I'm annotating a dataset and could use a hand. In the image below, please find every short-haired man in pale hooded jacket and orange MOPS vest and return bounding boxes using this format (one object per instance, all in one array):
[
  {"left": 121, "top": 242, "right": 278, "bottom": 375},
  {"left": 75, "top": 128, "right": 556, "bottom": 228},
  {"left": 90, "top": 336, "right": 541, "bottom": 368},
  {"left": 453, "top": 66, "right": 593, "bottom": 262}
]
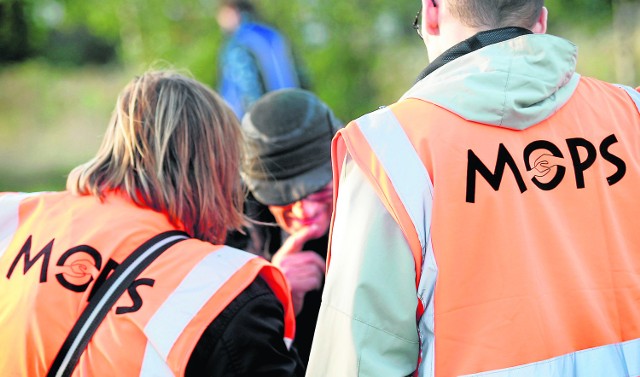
[{"left": 307, "top": 0, "right": 640, "bottom": 377}]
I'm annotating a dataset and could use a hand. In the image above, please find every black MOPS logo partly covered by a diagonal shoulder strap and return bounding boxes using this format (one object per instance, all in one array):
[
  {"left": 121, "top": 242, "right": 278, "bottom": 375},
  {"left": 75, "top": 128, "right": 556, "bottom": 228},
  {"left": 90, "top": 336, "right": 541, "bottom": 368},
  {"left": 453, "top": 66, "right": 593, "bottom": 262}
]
[{"left": 6, "top": 236, "right": 155, "bottom": 314}]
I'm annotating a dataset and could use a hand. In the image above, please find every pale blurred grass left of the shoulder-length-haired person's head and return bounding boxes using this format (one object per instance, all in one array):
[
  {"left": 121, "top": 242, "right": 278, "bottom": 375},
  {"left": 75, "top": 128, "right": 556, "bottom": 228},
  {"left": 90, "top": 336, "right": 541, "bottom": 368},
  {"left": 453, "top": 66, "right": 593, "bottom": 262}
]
[{"left": 0, "top": 61, "right": 132, "bottom": 191}]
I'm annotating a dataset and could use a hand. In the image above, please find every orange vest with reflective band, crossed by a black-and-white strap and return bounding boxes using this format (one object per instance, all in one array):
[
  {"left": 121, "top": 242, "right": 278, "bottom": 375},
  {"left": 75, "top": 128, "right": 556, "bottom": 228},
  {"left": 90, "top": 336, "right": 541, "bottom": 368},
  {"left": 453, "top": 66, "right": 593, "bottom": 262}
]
[{"left": 0, "top": 192, "right": 295, "bottom": 377}]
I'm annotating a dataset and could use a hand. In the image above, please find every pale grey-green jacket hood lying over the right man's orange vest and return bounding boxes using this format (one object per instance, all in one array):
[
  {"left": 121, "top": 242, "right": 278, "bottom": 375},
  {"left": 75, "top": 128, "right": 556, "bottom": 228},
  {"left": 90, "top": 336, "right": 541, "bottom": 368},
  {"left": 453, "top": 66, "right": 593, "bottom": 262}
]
[{"left": 402, "top": 34, "right": 580, "bottom": 130}]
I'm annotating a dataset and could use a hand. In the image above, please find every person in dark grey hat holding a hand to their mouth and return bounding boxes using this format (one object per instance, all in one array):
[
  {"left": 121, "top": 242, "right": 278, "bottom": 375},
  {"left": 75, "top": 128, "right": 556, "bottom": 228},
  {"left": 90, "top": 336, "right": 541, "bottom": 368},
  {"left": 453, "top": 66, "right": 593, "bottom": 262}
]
[{"left": 241, "top": 88, "right": 343, "bottom": 363}]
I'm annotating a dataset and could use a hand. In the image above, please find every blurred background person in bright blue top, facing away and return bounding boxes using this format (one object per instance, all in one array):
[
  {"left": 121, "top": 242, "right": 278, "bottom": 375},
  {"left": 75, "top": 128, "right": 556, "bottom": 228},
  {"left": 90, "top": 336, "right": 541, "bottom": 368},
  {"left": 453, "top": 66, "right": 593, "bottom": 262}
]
[{"left": 217, "top": 0, "right": 304, "bottom": 119}]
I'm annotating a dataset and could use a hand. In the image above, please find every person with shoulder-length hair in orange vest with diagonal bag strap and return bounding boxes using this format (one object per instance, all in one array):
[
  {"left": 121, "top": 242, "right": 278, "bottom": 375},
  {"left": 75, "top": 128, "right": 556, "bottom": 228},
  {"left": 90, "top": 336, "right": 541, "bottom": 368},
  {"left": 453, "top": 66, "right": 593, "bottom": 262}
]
[{"left": 0, "top": 71, "right": 304, "bottom": 376}]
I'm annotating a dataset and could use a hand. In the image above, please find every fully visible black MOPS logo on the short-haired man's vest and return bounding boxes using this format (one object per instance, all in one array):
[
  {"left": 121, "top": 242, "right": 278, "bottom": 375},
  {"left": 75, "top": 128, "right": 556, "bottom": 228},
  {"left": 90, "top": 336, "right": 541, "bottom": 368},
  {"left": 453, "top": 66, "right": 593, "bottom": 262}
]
[{"left": 466, "top": 134, "right": 627, "bottom": 203}]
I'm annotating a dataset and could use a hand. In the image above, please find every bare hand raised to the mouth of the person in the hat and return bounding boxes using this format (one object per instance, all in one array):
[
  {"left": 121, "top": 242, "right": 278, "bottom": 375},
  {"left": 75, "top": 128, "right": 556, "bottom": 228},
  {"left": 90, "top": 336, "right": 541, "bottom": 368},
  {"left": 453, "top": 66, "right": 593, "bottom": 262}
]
[{"left": 271, "top": 227, "right": 326, "bottom": 315}]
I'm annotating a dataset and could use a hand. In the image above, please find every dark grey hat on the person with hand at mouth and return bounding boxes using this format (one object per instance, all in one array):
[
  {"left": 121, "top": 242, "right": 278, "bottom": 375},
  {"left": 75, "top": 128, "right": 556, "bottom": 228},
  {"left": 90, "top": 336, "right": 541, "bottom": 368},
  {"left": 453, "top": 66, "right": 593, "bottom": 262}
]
[{"left": 241, "top": 89, "right": 342, "bottom": 205}]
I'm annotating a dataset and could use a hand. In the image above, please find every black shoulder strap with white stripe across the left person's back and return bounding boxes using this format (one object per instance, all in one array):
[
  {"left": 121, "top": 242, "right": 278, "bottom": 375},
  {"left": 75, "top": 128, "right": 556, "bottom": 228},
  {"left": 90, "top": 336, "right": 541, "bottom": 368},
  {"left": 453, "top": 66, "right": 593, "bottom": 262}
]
[{"left": 47, "top": 231, "right": 189, "bottom": 377}]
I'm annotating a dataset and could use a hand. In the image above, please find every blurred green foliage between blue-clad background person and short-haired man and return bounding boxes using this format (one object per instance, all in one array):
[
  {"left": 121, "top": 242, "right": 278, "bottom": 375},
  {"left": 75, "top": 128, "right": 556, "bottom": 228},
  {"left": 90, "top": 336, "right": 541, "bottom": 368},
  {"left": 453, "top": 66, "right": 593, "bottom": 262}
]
[{"left": 260, "top": 0, "right": 420, "bottom": 120}]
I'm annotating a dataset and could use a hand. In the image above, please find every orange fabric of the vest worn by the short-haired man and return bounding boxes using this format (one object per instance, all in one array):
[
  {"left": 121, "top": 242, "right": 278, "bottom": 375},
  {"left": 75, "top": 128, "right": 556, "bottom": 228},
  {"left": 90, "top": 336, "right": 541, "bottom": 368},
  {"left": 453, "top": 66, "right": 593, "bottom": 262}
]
[{"left": 342, "top": 78, "right": 640, "bottom": 376}]
